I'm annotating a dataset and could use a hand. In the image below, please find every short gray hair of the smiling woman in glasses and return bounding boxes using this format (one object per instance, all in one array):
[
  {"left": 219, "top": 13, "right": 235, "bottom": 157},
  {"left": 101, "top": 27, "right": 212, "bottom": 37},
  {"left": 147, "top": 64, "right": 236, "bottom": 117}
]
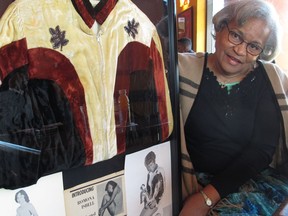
[{"left": 212, "top": 0, "right": 282, "bottom": 61}]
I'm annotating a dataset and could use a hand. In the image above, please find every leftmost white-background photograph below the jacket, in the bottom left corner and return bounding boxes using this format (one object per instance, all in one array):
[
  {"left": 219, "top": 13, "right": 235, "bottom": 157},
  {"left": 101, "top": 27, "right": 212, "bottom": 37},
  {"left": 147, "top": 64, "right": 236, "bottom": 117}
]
[{"left": 0, "top": 173, "right": 66, "bottom": 216}]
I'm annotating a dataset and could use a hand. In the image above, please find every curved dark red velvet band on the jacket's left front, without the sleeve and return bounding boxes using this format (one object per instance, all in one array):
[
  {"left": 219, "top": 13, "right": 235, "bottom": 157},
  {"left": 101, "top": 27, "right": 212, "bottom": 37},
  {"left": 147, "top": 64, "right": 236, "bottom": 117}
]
[{"left": 29, "top": 48, "right": 93, "bottom": 164}]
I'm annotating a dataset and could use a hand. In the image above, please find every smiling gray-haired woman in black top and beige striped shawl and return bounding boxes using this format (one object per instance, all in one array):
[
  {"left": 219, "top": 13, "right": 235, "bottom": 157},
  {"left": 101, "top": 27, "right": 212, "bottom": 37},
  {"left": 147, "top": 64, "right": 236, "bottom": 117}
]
[{"left": 178, "top": 0, "right": 288, "bottom": 216}]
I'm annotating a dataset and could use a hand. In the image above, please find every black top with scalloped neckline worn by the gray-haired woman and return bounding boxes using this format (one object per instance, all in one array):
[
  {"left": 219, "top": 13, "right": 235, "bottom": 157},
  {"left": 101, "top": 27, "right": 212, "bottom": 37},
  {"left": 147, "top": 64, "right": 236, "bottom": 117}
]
[{"left": 185, "top": 57, "right": 280, "bottom": 197}]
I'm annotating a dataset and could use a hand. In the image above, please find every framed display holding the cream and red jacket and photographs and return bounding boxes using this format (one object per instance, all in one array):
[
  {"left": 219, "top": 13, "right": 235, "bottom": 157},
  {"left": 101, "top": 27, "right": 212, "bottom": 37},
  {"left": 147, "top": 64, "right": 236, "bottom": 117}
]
[{"left": 0, "top": 0, "right": 181, "bottom": 216}]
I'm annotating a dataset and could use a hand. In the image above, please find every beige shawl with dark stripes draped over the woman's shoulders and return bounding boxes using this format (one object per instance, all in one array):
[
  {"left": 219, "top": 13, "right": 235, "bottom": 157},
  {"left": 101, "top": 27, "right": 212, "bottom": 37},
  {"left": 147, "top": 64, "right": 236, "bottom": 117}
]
[{"left": 178, "top": 53, "right": 288, "bottom": 199}]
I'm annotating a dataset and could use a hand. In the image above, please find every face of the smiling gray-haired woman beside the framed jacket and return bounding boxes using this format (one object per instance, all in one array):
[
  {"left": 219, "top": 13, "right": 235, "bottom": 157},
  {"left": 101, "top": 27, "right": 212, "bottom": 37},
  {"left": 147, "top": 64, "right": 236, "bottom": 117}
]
[{"left": 215, "top": 19, "right": 270, "bottom": 75}]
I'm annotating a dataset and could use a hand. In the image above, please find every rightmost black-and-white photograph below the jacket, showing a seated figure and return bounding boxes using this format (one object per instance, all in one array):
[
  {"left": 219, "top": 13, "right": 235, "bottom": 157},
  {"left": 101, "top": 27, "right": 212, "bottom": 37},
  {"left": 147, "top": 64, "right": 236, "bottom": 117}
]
[{"left": 125, "top": 142, "right": 172, "bottom": 216}]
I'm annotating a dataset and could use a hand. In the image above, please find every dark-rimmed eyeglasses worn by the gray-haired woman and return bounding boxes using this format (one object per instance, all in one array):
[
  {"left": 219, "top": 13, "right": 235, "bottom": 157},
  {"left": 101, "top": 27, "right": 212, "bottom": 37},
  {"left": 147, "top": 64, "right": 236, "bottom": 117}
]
[{"left": 226, "top": 25, "right": 263, "bottom": 56}]
